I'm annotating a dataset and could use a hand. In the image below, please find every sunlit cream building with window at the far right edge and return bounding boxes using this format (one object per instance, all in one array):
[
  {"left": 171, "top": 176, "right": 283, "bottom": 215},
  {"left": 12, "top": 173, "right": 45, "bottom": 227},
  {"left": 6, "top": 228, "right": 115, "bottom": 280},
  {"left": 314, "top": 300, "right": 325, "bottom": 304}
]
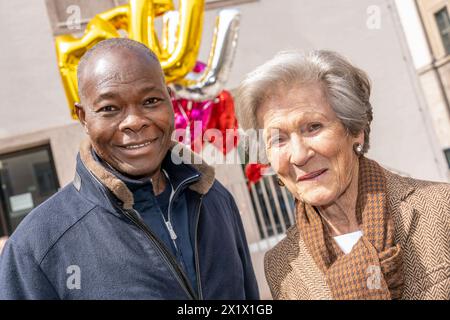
[{"left": 396, "top": 0, "right": 450, "bottom": 172}]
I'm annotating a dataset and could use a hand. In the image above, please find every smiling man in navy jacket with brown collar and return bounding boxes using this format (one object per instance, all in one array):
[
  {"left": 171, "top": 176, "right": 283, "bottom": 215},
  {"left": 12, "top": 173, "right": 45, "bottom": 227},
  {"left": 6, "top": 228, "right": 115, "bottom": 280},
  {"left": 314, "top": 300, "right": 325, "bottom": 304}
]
[{"left": 0, "top": 39, "right": 258, "bottom": 299}]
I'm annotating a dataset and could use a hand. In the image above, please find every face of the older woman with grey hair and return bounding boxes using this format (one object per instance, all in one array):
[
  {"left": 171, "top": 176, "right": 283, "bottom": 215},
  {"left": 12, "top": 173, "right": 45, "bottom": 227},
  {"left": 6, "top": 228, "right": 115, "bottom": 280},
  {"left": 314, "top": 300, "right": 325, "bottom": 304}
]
[{"left": 257, "top": 83, "right": 364, "bottom": 206}]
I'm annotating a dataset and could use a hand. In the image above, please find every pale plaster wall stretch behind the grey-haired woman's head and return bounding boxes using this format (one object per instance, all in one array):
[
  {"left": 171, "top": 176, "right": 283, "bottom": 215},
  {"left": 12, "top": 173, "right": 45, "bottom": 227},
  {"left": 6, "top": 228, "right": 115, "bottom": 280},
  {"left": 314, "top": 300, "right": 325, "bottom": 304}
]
[{"left": 201, "top": 0, "right": 447, "bottom": 181}]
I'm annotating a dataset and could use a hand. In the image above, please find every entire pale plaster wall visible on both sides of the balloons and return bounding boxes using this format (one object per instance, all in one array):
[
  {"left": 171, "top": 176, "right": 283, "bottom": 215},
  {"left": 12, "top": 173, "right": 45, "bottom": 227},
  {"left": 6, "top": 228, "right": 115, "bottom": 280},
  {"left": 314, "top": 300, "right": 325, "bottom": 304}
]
[{"left": 0, "top": 0, "right": 447, "bottom": 180}]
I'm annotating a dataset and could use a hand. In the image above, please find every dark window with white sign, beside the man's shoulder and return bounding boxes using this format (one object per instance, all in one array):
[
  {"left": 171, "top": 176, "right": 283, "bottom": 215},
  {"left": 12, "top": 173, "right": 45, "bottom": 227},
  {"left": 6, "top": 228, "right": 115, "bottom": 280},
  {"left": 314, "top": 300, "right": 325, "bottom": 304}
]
[{"left": 0, "top": 145, "right": 59, "bottom": 234}]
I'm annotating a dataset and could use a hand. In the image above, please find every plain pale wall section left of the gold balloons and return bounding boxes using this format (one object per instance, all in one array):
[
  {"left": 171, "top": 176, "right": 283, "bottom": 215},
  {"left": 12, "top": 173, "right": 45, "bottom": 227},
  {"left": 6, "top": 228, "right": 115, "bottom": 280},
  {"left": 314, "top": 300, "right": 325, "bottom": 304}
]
[{"left": 0, "top": 0, "right": 73, "bottom": 138}]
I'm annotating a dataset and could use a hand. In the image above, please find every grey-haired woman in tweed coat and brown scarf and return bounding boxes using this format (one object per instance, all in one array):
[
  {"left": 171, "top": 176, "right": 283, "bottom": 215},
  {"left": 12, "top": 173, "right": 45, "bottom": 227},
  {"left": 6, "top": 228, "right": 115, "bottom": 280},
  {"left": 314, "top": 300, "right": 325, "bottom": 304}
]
[{"left": 237, "top": 51, "right": 450, "bottom": 299}]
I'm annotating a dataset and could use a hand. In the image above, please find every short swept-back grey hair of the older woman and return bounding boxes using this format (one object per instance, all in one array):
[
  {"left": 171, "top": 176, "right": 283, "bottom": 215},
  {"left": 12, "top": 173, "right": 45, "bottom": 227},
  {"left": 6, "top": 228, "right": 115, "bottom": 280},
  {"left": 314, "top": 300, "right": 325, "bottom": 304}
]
[{"left": 236, "top": 50, "right": 373, "bottom": 152}]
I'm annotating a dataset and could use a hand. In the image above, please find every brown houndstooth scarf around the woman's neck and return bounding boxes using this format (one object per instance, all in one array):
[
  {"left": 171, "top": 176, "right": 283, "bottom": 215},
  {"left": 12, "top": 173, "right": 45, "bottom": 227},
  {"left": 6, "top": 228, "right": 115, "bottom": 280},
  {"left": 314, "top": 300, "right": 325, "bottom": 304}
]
[{"left": 297, "top": 157, "right": 404, "bottom": 300}]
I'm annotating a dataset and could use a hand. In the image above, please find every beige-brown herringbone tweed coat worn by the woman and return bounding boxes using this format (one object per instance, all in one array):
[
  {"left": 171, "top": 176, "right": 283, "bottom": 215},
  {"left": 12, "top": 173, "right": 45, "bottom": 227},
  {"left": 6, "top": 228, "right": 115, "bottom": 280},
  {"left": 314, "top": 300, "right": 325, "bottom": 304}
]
[{"left": 264, "top": 170, "right": 450, "bottom": 299}]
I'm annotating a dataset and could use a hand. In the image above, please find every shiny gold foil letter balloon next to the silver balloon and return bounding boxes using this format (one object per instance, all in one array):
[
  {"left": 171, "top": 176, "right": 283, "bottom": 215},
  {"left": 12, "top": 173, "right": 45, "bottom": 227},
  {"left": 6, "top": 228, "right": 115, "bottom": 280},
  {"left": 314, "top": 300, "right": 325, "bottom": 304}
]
[{"left": 99, "top": 0, "right": 205, "bottom": 82}]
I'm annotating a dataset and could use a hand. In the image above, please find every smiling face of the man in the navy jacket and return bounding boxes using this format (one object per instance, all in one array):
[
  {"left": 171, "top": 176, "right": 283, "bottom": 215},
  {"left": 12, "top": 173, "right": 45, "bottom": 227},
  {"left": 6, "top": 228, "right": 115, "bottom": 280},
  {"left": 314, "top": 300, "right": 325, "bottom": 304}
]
[{"left": 77, "top": 48, "right": 174, "bottom": 177}]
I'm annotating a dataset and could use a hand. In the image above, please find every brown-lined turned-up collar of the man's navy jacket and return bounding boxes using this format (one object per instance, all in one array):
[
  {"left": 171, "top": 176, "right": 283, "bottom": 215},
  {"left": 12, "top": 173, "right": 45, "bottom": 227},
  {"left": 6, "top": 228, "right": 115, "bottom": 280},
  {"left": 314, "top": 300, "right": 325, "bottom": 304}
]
[{"left": 80, "top": 139, "right": 215, "bottom": 209}]
